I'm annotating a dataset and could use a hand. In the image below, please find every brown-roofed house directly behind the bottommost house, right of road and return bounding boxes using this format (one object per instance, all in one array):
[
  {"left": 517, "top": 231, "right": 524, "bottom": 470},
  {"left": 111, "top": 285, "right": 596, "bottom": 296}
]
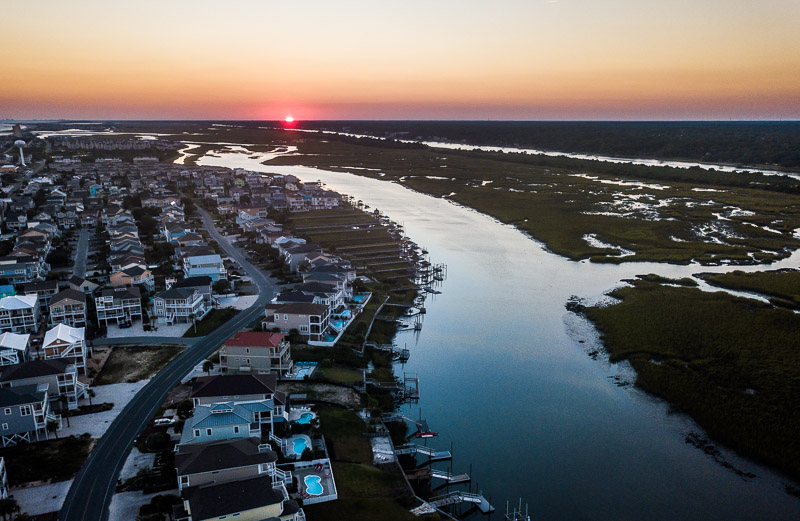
[{"left": 175, "top": 438, "right": 292, "bottom": 490}]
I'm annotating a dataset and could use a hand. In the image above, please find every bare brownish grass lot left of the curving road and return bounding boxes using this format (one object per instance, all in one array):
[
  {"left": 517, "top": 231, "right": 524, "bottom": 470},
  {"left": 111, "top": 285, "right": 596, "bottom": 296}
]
[{"left": 93, "top": 346, "right": 183, "bottom": 385}]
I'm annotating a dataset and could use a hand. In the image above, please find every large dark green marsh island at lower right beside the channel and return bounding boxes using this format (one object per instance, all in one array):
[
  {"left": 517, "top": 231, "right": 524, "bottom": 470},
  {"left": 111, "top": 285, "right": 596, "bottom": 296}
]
[{"left": 586, "top": 280, "right": 800, "bottom": 478}]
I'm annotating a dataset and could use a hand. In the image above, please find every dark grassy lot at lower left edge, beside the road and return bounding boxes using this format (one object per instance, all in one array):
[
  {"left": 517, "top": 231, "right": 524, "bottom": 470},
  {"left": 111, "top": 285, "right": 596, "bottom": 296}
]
[{"left": 0, "top": 430, "right": 94, "bottom": 485}]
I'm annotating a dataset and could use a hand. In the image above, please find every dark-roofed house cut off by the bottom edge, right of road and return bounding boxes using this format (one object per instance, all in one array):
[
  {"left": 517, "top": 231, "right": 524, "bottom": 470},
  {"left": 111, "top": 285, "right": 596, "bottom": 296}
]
[{"left": 174, "top": 476, "right": 306, "bottom": 521}]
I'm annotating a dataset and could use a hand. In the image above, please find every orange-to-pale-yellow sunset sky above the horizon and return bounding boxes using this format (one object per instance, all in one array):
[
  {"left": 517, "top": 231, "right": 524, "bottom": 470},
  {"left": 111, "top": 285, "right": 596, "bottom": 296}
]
[{"left": 0, "top": 0, "right": 800, "bottom": 120}]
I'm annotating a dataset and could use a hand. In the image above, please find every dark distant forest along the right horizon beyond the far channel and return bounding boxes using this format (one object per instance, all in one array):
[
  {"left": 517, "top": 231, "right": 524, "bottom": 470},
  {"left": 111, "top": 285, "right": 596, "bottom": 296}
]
[{"left": 288, "top": 121, "right": 800, "bottom": 168}]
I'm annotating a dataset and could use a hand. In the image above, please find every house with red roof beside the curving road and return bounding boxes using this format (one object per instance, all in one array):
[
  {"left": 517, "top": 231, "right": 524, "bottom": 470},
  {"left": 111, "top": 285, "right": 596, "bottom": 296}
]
[{"left": 219, "top": 331, "right": 294, "bottom": 375}]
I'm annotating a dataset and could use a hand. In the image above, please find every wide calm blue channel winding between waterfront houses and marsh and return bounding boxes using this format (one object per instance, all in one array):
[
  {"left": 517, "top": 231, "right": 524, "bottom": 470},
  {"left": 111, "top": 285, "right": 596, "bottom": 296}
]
[{"left": 198, "top": 151, "right": 800, "bottom": 521}]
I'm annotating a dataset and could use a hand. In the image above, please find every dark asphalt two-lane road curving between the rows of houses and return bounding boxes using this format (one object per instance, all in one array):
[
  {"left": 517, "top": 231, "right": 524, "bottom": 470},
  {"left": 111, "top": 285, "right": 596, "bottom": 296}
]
[{"left": 58, "top": 208, "right": 275, "bottom": 521}]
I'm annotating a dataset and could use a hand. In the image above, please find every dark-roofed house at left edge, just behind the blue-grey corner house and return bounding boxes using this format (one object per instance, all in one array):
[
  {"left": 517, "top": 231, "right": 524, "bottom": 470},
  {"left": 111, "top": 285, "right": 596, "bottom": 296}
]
[{"left": 0, "top": 358, "right": 89, "bottom": 410}]
